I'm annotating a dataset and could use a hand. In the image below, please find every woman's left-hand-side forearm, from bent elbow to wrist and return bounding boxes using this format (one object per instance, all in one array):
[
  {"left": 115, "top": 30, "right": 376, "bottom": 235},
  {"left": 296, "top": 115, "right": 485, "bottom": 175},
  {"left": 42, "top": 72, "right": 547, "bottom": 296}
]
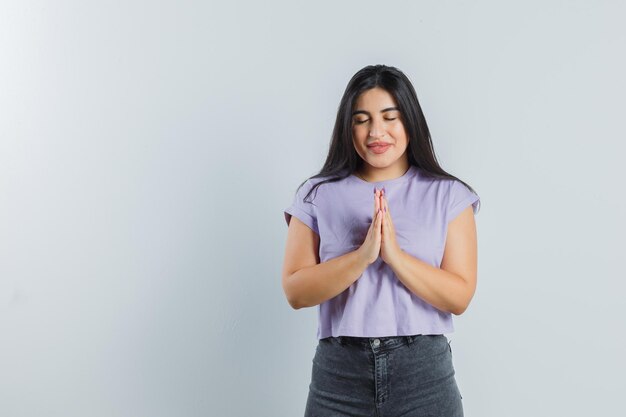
[{"left": 285, "top": 250, "right": 368, "bottom": 309}]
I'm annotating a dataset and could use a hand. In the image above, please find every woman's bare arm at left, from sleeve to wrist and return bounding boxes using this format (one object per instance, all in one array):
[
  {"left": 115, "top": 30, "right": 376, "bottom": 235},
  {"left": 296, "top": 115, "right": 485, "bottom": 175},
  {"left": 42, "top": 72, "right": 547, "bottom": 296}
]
[{"left": 282, "top": 216, "right": 369, "bottom": 310}]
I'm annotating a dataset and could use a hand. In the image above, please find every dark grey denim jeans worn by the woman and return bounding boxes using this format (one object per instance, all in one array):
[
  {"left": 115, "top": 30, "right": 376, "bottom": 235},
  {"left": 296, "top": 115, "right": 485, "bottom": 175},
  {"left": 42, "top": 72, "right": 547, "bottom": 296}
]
[{"left": 304, "top": 334, "right": 463, "bottom": 417}]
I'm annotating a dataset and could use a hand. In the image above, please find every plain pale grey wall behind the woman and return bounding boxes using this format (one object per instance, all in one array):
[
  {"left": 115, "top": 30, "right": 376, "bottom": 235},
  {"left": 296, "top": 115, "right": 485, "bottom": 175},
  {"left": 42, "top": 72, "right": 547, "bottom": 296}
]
[{"left": 0, "top": 0, "right": 626, "bottom": 417}]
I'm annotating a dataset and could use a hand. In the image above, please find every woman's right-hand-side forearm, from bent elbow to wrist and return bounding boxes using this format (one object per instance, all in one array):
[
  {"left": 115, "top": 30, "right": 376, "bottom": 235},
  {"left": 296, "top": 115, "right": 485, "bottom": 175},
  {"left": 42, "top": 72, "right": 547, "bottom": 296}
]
[{"left": 389, "top": 251, "right": 473, "bottom": 315}]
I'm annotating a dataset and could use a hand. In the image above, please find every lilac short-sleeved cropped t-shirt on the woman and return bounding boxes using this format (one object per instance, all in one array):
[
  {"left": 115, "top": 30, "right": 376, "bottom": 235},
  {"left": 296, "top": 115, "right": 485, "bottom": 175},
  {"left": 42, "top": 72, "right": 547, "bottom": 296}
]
[{"left": 284, "top": 165, "right": 479, "bottom": 339}]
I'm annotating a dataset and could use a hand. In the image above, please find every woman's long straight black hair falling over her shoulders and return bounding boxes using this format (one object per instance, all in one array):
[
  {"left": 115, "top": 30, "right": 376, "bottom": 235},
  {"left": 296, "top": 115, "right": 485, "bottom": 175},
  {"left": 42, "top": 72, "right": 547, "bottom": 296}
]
[{"left": 298, "top": 65, "right": 480, "bottom": 211}]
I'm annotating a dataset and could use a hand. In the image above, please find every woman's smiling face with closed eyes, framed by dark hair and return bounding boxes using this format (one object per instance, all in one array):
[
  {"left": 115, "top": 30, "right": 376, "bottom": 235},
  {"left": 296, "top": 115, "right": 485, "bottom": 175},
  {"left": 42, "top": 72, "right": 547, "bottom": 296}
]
[{"left": 352, "top": 87, "right": 408, "bottom": 171}]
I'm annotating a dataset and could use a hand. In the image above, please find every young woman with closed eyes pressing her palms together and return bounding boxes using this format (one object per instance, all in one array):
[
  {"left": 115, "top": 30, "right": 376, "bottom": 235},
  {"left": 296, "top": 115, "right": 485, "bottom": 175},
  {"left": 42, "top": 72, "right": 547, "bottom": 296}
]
[{"left": 282, "top": 65, "right": 479, "bottom": 417}]
